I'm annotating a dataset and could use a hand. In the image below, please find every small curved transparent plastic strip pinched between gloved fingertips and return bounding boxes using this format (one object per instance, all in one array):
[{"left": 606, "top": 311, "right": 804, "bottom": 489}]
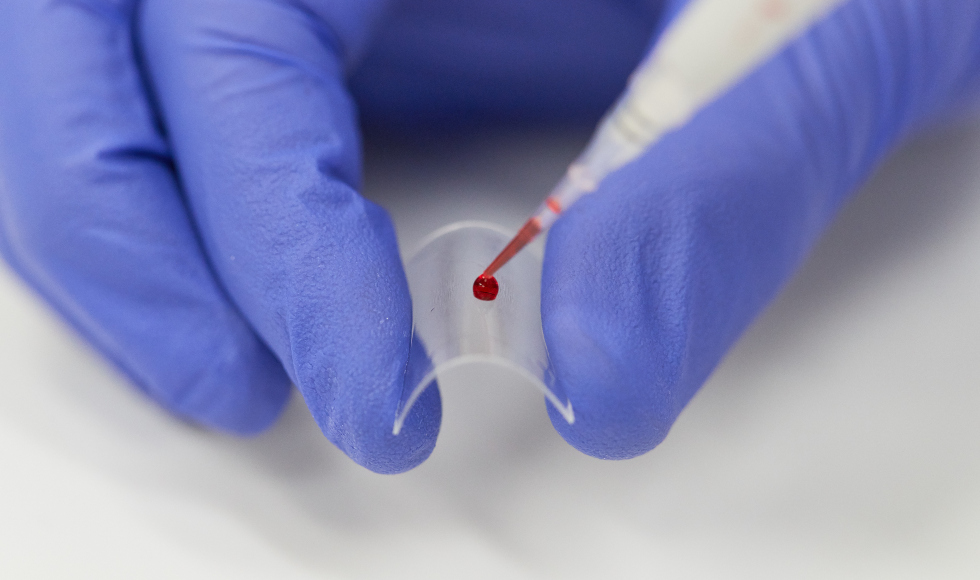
[{"left": 393, "top": 221, "right": 575, "bottom": 435}]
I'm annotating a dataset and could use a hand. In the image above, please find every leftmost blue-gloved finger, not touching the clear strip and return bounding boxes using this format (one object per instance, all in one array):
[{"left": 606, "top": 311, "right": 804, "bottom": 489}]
[{"left": 0, "top": 0, "right": 289, "bottom": 433}]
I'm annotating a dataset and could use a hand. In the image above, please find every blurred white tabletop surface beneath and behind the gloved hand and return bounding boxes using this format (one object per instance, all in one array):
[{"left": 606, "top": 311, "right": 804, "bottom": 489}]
[{"left": 0, "top": 125, "right": 980, "bottom": 579}]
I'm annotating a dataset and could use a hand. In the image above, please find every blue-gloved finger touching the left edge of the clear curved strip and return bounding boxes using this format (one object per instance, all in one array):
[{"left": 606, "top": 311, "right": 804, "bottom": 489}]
[{"left": 140, "top": 0, "right": 440, "bottom": 472}]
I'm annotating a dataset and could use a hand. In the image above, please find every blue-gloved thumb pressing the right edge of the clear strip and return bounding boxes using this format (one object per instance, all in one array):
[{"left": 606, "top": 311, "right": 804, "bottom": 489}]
[{"left": 543, "top": 0, "right": 980, "bottom": 458}]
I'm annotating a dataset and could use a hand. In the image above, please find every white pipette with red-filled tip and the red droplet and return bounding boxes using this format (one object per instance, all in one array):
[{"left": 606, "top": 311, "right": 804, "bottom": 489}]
[{"left": 473, "top": 0, "right": 844, "bottom": 300}]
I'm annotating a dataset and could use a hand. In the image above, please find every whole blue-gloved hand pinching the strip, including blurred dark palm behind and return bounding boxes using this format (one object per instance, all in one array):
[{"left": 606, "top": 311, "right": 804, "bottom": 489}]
[{"left": 0, "top": 0, "right": 980, "bottom": 472}]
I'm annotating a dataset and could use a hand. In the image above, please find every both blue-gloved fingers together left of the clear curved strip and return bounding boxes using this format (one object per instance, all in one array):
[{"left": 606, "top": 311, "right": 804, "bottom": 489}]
[{"left": 0, "top": 0, "right": 441, "bottom": 472}]
